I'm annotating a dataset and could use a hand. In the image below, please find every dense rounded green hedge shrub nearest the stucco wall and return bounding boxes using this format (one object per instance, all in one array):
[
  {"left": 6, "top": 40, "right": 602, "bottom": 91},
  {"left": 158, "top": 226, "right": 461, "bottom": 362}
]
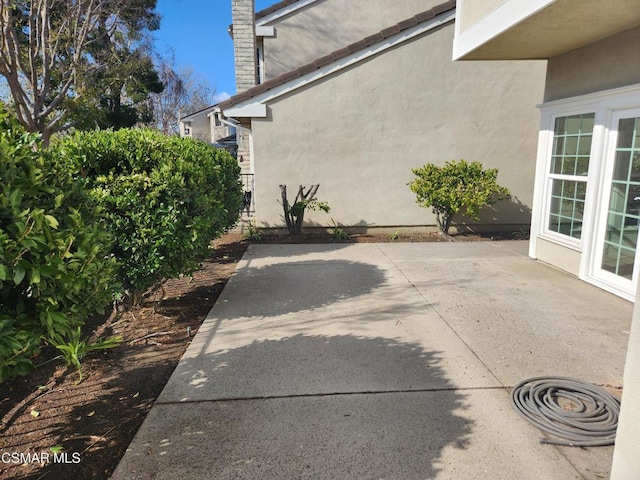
[{"left": 54, "top": 129, "right": 242, "bottom": 302}]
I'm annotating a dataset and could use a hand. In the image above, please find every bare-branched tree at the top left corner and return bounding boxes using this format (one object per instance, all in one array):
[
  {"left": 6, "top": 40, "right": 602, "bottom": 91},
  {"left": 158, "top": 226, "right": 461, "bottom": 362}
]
[{"left": 0, "top": 0, "right": 155, "bottom": 142}]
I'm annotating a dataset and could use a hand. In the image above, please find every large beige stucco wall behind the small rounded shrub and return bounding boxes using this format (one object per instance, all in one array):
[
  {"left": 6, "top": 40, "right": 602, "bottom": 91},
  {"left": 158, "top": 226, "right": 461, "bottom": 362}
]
[{"left": 252, "top": 23, "right": 545, "bottom": 231}]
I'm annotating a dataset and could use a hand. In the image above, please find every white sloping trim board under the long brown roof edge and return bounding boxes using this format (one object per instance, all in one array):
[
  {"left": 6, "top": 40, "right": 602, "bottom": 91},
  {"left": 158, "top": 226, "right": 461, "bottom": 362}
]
[{"left": 224, "top": 9, "right": 456, "bottom": 117}]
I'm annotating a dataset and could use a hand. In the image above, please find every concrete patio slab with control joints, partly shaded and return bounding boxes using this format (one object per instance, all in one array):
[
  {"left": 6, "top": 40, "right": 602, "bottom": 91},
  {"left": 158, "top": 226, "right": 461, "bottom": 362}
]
[{"left": 112, "top": 241, "right": 632, "bottom": 480}]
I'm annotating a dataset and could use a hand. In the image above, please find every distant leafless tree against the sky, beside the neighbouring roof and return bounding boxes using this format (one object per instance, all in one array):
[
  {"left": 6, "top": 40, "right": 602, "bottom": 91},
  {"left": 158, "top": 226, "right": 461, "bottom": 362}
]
[{"left": 150, "top": 54, "right": 215, "bottom": 134}]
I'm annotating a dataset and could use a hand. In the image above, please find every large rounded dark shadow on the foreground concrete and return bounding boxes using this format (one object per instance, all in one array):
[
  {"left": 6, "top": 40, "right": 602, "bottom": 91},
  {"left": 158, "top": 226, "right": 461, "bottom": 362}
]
[{"left": 113, "top": 335, "right": 473, "bottom": 480}]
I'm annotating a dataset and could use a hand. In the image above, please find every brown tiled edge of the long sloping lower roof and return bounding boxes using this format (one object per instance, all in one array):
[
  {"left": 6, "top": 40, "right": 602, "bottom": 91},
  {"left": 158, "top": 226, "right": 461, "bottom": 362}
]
[{"left": 218, "top": 0, "right": 456, "bottom": 110}]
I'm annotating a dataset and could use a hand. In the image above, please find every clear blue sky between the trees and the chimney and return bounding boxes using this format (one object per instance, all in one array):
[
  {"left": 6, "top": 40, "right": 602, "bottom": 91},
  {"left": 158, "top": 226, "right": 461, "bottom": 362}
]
[{"left": 154, "top": 0, "right": 277, "bottom": 98}]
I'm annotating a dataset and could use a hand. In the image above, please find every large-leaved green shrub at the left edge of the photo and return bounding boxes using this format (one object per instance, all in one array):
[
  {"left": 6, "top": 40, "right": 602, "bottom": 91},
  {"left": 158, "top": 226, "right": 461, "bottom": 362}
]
[{"left": 0, "top": 109, "right": 115, "bottom": 382}]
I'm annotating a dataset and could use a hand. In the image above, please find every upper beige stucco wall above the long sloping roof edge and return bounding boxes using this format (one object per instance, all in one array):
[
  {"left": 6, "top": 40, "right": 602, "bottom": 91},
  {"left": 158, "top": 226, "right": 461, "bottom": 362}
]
[{"left": 263, "top": 0, "right": 442, "bottom": 80}]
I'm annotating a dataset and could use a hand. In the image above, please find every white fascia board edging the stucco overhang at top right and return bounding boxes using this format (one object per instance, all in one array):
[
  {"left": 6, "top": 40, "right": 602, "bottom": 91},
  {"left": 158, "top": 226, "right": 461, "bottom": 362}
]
[{"left": 453, "top": 0, "right": 557, "bottom": 61}]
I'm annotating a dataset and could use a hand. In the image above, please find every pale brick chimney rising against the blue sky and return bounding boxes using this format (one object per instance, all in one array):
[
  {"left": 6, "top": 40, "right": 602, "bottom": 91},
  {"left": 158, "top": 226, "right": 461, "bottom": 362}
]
[{"left": 231, "top": 0, "right": 257, "bottom": 93}]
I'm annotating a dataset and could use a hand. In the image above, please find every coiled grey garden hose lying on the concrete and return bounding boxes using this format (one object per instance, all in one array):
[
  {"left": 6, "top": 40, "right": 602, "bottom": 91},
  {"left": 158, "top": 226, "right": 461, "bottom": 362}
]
[{"left": 511, "top": 377, "right": 620, "bottom": 447}]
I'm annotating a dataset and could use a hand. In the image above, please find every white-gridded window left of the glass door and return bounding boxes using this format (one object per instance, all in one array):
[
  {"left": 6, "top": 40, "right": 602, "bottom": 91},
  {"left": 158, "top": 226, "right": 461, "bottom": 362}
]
[{"left": 547, "top": 113, "right": 595, "bottom": 239}]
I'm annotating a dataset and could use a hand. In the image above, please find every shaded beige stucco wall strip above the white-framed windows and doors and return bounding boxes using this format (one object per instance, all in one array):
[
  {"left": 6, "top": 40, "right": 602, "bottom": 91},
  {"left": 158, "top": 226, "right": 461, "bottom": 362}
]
[{"left": 544, "top": 27, "right": 640, "bottom": 101}]
